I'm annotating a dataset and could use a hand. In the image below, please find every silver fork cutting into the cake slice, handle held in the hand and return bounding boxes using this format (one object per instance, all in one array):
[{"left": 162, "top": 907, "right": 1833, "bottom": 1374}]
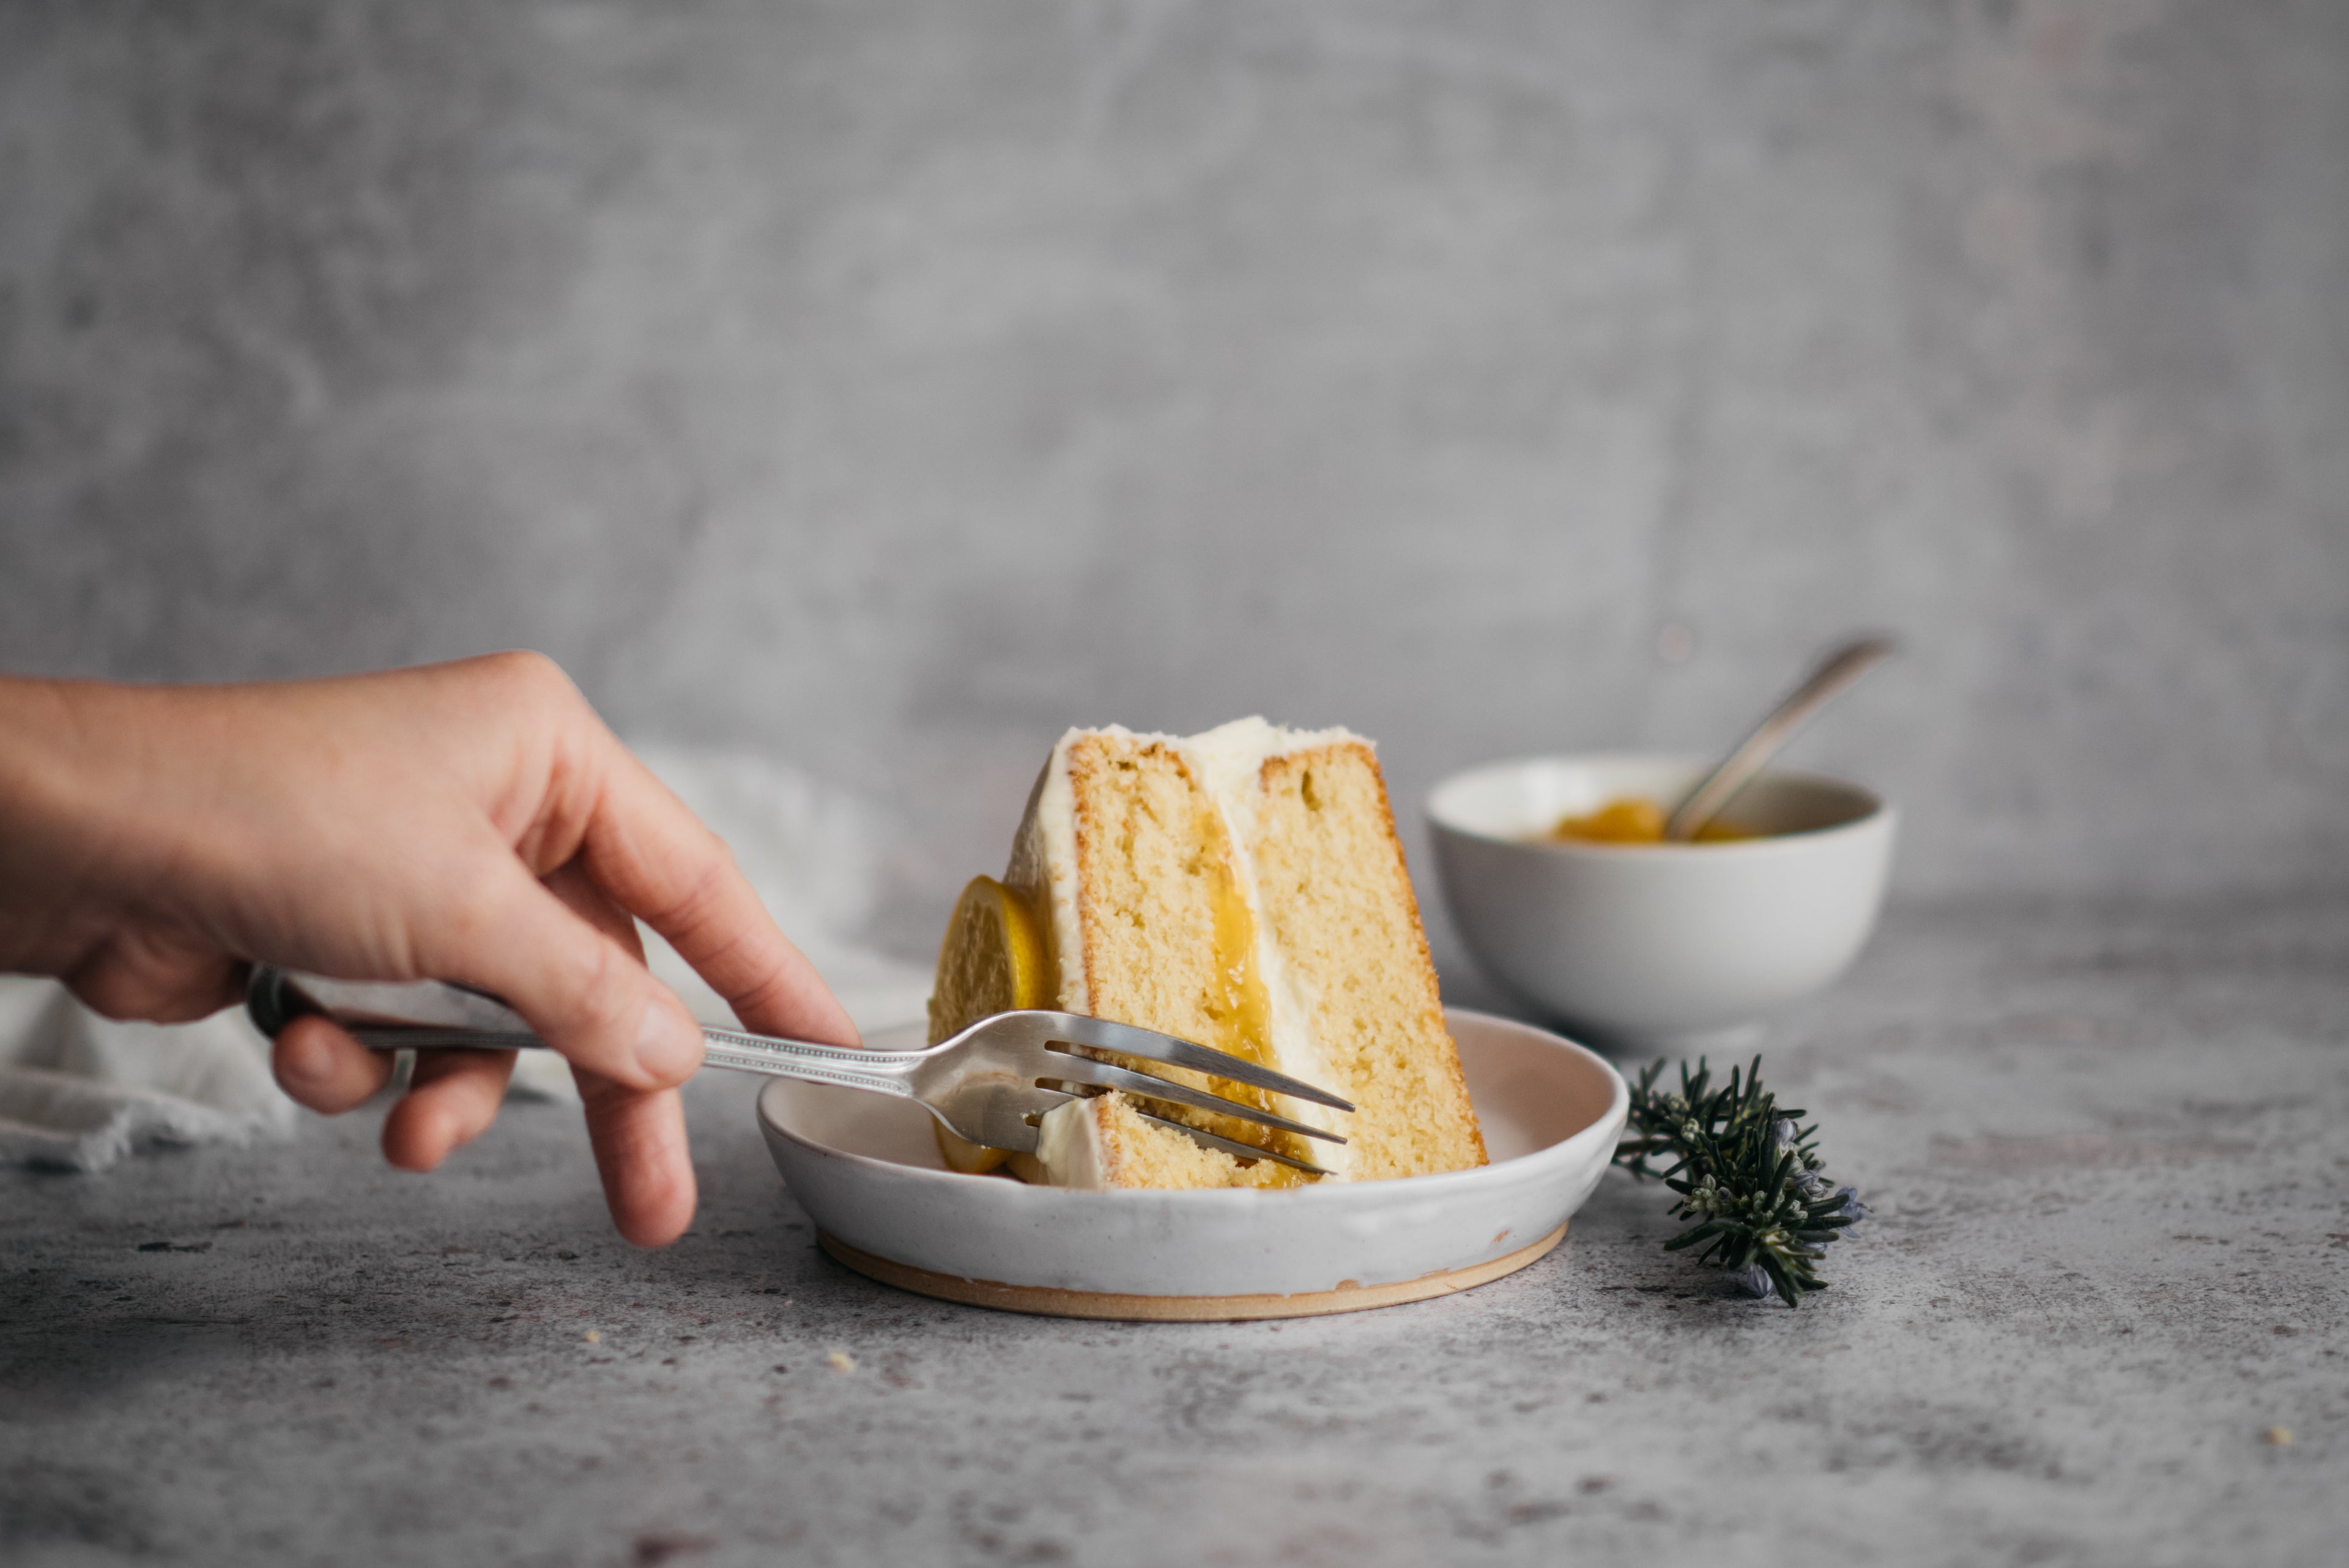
[{"left": 244, "top": 964, "right": 1353, "bottom": 1175}]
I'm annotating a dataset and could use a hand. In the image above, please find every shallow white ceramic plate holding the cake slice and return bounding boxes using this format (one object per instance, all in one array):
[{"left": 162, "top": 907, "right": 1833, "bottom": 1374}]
[{"left": 759, "top": 1008, "right": 1630, "bottom": 1319}]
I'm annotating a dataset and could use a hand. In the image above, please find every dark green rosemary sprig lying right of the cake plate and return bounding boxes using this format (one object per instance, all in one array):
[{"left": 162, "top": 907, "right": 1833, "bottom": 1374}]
[{"left": 1614, "top": 1055, "right": 1868, "bottom": 1307}]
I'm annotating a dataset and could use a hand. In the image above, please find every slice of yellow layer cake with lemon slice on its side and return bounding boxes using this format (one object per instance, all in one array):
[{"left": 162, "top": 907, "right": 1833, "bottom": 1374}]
[{"left": 930, "top": 719, "right": 1485, "bottom": 1187}]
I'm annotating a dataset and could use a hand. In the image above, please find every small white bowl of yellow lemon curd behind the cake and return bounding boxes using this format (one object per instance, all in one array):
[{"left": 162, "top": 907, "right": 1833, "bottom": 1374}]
[{"left": 1428, "top": 752, "right": 1893, "bottom": 1051}]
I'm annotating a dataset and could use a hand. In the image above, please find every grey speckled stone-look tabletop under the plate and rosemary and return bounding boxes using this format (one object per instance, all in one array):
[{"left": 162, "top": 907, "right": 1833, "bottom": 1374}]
[{"left": 13, "top": 898, "right": 2349, "bottom": 1568}]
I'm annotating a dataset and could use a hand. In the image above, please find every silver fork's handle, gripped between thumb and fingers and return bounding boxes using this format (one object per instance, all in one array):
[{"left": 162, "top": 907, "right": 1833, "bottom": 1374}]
[{"left": 244, "top": 964, "right": 926, "bottom": 1100}]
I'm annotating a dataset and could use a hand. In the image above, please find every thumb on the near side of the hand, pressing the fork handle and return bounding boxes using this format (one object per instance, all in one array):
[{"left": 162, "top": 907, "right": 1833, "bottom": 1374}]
[{"left": 418, "top": 846, "right": 702, "bottom": 1093}]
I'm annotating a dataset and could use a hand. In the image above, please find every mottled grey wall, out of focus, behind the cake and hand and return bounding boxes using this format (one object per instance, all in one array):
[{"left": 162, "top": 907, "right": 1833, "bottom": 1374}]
[{"left": 0, "top": 0, "right": 2349, "bottom": 945}]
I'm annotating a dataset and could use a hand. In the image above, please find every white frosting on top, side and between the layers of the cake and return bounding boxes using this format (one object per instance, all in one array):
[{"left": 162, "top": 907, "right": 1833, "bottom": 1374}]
[{"left": 1010, "top": 717, "right": 1370, "bottom": 1187}]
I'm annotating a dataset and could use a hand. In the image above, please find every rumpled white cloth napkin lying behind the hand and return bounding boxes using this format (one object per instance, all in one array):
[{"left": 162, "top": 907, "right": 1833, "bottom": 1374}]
[{"left": 0, "top": 748, "right": 930, "bottom": 1171}]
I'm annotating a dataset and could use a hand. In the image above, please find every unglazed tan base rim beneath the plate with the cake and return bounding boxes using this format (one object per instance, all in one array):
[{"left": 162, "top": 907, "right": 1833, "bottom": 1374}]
[{"left": 815, "top": 1225, "right": 1567, "bottom": 1323}]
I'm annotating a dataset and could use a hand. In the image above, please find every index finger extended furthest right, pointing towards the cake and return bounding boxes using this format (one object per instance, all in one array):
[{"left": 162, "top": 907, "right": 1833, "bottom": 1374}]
[{"left": 582, "top": 740, "right": 858, "bottom": 1046}]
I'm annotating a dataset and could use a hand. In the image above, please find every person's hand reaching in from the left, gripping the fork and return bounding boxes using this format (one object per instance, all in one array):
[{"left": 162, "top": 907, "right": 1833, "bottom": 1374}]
[{"left": 0, "top": 653, "right": 858, "bottom": 1246}]
